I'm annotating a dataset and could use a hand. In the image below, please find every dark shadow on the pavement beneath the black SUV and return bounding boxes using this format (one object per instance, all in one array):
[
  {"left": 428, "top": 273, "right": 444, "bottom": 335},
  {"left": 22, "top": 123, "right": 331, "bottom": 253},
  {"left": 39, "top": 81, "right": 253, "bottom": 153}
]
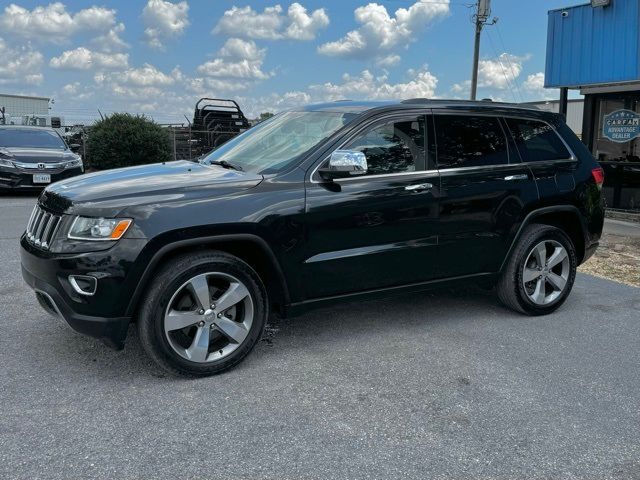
[{"left": 40, "top": 287, "right": 510, "bottom": 381}]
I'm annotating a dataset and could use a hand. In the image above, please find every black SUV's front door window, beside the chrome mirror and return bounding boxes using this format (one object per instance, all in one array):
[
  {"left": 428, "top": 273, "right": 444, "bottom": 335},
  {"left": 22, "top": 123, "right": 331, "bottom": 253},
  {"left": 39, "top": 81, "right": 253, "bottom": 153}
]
[{"left": 344, "top": 117, "right": 424, "bottom": 175}]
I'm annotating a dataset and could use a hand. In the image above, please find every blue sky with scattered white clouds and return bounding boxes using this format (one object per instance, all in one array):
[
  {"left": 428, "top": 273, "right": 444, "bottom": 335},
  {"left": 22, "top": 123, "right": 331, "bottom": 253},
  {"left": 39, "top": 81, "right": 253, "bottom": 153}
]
[{"left": 0, "top": 0, "right": 580, "bottom": 123}]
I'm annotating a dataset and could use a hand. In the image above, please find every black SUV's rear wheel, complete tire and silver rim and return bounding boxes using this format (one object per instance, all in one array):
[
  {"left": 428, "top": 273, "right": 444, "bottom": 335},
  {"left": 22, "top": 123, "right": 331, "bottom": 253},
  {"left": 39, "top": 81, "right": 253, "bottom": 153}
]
[{"left": 497, "top": 224, "right": 577, "bottom": 315}]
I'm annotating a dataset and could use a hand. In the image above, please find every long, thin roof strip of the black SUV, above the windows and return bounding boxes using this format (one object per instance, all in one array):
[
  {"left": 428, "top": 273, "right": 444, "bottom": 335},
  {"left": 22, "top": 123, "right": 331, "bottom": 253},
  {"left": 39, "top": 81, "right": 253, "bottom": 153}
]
[{"left": 303, "top": 98, "right": 557, "bottom": 117}]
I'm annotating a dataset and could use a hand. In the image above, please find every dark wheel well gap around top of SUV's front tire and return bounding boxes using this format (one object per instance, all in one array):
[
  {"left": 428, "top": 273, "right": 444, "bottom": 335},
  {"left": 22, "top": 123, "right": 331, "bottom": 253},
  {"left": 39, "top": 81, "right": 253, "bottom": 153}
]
[{"left": 130, "top": 238, "right": 289, "bottom": 318}]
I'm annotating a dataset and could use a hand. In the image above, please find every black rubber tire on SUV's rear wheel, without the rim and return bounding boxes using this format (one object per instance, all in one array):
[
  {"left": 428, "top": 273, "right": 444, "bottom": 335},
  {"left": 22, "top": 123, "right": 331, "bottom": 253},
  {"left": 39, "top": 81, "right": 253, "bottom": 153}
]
[{"left": 496, "top": 224, "right": 578, "bottom": 315}]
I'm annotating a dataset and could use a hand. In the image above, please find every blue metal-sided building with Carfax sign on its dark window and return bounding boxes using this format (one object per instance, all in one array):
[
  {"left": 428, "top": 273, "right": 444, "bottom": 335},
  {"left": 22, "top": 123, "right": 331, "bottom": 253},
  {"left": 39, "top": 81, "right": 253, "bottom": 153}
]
[{"left": 545, "top": 0, "right": 640, "bottom": 210}]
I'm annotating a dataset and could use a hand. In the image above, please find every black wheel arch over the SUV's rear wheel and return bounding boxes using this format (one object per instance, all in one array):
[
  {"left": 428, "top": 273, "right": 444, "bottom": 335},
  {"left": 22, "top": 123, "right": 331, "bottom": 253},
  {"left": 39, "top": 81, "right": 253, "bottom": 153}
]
[{"left": 500, "top": 205, "right": 587, "bottom": 272}]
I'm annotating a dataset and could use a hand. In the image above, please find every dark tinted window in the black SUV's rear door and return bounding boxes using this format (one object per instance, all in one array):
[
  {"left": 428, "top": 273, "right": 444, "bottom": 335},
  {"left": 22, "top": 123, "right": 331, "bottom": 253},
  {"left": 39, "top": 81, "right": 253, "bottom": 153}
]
[{"left": 435, "top": 115, "right": 509, "bottom": 169}]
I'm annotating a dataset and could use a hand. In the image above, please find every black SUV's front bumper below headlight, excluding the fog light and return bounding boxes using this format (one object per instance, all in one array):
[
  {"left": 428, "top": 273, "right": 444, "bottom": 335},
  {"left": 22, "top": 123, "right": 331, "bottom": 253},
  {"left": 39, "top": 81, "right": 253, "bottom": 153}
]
[{"left": 20, "top": 236, "right": 146, "bottom": 349}]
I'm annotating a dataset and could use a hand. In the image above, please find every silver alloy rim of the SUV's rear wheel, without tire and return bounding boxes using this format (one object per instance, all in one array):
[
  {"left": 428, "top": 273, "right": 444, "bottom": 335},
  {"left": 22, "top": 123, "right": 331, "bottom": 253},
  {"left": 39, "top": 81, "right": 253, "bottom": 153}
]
[{"left": 522, "top": 240, "right": 571, "bottom": 305}]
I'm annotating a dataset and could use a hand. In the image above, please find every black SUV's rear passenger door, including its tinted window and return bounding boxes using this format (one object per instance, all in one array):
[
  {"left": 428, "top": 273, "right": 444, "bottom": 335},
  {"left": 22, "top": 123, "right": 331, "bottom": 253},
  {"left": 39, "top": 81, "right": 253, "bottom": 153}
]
[{"left": 433, "top": 110, "right": 538, "bottom": 277}]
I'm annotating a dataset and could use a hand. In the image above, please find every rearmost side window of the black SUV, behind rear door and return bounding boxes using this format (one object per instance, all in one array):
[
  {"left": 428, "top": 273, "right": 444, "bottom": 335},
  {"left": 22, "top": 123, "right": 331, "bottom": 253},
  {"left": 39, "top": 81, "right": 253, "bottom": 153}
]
[{"left": 505, "top": 118, "right": 571, "bottom": 162}]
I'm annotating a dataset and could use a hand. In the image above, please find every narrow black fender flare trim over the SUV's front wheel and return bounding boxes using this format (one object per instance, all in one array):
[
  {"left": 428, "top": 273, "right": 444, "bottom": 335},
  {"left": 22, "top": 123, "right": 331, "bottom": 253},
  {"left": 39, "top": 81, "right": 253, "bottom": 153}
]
[{"left": 126, "top": 233, "right": 291, "bottom": 317}]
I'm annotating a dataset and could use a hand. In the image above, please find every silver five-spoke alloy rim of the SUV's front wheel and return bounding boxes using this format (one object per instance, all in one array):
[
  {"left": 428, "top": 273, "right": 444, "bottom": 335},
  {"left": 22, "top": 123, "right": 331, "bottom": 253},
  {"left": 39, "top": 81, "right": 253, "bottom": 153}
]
[{"left": 163, "top": 272, "right": 254, "bottom": 363}]
